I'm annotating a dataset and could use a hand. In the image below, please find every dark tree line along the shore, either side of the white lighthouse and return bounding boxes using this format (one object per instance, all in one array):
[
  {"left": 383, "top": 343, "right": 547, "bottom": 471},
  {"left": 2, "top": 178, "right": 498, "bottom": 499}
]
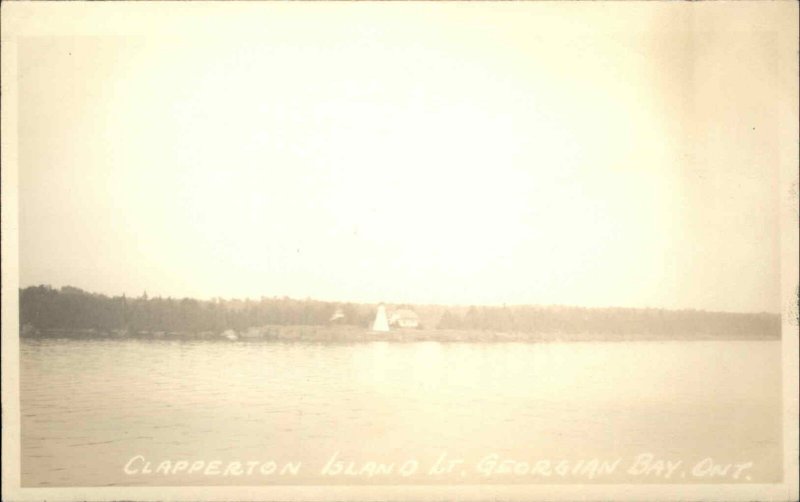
[{"left": 20, "top": 286, "right": 781, "bottom": 338}]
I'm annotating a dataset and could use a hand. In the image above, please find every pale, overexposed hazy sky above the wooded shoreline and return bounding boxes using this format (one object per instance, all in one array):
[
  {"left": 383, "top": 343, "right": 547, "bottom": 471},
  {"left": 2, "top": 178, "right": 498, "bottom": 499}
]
[{"left": 18, "top": 2, "right": 791, "bottom": 311}]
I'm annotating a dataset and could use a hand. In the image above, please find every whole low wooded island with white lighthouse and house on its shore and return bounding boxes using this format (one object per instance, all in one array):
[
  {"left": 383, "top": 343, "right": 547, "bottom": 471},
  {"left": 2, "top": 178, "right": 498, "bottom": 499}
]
[{"left": 19, "top": 285, "right": 781, "bottom": 342}]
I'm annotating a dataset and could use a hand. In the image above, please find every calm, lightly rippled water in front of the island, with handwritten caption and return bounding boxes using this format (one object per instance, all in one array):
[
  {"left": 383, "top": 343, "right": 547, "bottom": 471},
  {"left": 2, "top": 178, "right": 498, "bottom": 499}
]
[{"left": 20, "top": 339, "right": 782, "bottom": 486}]
